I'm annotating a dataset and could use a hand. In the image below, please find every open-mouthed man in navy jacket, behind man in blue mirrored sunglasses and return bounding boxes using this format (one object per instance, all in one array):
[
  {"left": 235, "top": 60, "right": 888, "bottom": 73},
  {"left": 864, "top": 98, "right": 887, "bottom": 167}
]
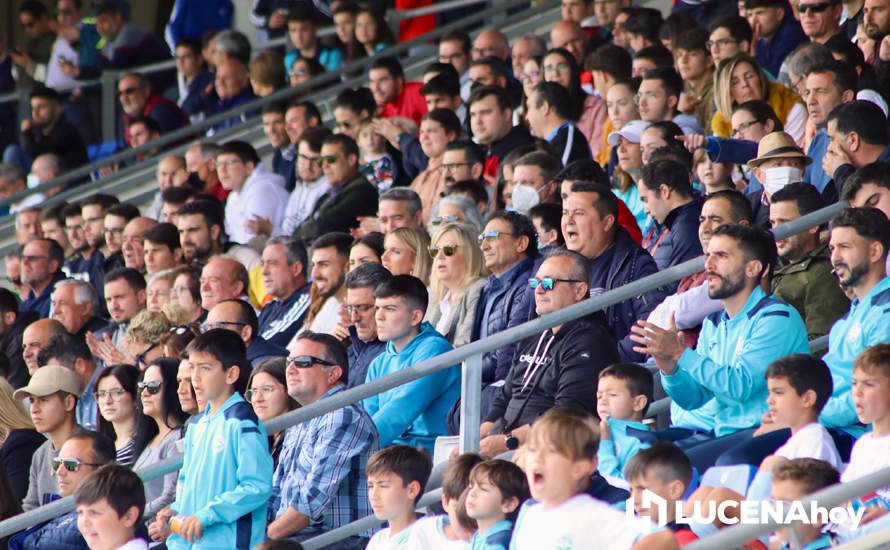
[{"left": 562, "top": 182, "right": 667, "bottom": 362}]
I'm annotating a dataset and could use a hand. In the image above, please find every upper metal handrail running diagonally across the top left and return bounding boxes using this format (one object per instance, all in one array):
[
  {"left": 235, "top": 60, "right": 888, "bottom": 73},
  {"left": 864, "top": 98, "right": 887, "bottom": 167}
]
[{"left": 0, "top": 0, "right": 559, "bottom": 208}]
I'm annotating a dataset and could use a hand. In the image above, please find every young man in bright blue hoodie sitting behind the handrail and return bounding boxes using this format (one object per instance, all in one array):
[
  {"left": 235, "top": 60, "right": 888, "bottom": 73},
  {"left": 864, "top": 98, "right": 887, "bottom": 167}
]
[{"left": 362, "top": 275, "right": 460, "bottom": 453}]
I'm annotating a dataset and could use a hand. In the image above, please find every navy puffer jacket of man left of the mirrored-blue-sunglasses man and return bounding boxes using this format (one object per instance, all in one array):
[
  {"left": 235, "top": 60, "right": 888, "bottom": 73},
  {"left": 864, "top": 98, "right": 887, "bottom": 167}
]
[{"left": 470, "top": 258, "right": 535, "bottom": 384}]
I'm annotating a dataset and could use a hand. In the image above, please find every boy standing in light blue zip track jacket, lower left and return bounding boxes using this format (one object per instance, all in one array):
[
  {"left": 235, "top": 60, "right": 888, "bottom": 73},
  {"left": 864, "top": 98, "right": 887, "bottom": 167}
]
[{"left": 149, "top": 329, "right": 272, "bottom": 550}]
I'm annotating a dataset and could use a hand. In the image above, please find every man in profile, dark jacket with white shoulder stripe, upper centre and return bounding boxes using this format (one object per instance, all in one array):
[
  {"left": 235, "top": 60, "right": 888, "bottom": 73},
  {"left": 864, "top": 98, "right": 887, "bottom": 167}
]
[{"left": 526, "top": 82, "right": 590, "bottom": 166}]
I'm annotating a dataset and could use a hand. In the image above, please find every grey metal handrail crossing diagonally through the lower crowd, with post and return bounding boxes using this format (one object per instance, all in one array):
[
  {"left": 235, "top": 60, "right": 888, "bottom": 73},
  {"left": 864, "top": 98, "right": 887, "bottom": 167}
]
[{"left": 0, "top": 197, "right": 846, "bottom": 538}]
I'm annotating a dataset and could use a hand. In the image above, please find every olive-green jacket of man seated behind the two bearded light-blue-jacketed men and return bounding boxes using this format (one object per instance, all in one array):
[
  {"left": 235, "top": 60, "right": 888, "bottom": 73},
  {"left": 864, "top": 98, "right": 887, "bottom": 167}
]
[{"left": 773, "top": 244, "right": 850, "bottom": 340}]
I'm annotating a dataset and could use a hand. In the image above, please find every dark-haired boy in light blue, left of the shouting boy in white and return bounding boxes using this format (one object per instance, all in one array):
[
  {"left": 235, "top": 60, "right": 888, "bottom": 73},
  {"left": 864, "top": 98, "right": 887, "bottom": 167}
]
[{"left": 466, "top": 459, "right": 531, "bottom": 550}]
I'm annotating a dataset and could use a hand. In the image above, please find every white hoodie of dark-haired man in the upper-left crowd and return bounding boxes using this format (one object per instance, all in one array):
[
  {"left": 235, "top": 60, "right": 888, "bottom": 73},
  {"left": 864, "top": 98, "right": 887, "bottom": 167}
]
[{"left": 226, "top": 164, "right": 287, "bottom": 244}]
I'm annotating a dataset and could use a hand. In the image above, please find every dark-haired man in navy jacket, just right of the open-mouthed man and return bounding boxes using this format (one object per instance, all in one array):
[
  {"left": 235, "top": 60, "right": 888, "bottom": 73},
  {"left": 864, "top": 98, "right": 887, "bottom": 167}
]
[{"left": 637, "top": 160, "right": 702, "bottom": 276}]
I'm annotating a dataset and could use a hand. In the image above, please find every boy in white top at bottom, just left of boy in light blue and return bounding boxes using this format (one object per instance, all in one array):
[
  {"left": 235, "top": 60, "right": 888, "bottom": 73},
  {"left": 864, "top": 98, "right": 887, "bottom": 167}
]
[{"left": 408, "top": 453, "right": 484, "bottom": 550}]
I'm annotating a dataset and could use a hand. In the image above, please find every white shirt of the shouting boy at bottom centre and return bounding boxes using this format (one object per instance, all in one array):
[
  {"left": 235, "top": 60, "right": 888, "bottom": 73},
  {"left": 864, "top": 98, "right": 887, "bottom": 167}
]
[{"left": 510, "top": 494, "right": 648, "bottom": 550}]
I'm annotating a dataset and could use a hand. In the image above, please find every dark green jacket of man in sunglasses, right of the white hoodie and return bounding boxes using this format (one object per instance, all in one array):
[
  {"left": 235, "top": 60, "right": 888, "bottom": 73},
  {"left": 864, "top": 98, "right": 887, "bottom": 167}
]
[{"left": 294, "top": 173, "right": 377, "bottom": 243}]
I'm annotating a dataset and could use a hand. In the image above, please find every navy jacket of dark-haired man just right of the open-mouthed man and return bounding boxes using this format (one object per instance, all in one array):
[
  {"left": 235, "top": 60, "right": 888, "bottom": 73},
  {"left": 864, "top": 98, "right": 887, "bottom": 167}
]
[{"left": 643, "top": 199, "right": 702, "bottom": 276}]
